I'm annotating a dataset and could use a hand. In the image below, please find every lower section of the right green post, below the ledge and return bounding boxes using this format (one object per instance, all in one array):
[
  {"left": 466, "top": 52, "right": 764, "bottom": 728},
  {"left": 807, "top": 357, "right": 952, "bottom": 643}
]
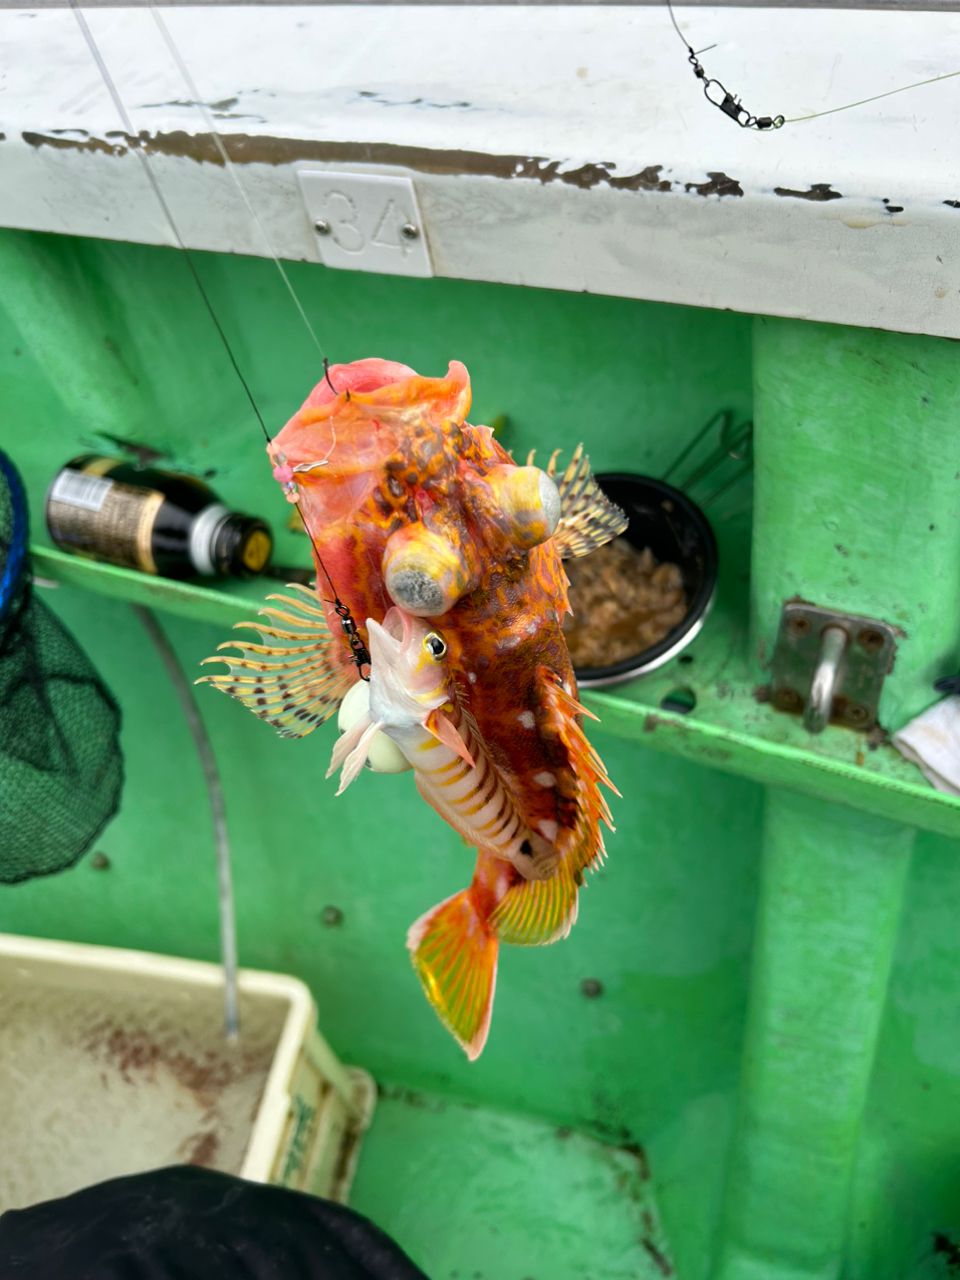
[{"left": 716, "top": 790, "right": 914, "bottom": 1280}]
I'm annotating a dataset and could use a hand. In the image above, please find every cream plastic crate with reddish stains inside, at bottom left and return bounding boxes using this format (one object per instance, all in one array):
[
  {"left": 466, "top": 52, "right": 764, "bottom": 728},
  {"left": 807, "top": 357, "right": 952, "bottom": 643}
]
[{"left": 0, "top": 934, "right": 375, "bottom": 1212}]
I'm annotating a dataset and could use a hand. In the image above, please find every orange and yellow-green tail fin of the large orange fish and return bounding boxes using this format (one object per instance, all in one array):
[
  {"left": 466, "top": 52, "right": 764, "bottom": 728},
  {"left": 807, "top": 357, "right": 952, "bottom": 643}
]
[{"left": 407, "top": 886, "right": 499, "bottom": 1062}]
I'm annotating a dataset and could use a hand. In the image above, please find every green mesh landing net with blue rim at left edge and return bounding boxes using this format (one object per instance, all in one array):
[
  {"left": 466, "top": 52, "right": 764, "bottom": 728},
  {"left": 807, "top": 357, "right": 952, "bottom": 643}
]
[{"left": 0, "top": 451, "right": 123, "bottom": 884}]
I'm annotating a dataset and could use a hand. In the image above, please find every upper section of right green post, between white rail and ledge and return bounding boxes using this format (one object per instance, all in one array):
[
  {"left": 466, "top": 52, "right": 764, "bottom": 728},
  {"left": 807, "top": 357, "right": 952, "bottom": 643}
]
[{"left": 753, "top": 319, "right": 960, "bottom": 730}]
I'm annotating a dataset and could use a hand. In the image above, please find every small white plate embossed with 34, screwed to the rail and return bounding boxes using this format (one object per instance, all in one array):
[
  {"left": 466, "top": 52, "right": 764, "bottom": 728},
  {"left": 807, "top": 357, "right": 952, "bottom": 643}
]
[{"left": 297, "top": 169, "right": 434, "bottom": 275}]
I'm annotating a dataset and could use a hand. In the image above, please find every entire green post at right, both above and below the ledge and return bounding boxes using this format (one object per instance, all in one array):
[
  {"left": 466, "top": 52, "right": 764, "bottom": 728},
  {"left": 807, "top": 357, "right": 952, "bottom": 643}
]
[{"left": 716, "top": 319, "right": 960, "bottom": 1280}]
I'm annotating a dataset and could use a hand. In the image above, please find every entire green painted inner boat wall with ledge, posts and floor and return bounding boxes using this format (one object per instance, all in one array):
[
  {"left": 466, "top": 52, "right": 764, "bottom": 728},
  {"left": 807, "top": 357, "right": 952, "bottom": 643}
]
[{"left": 0, "top": 230, "right": 960, "bottom": 1280}]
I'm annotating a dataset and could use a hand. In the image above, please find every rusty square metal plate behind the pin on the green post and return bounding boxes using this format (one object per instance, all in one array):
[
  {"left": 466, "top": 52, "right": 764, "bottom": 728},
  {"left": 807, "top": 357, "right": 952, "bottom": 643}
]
[{"left": 771, "top": 600, "right": 897, "bottom": 730}]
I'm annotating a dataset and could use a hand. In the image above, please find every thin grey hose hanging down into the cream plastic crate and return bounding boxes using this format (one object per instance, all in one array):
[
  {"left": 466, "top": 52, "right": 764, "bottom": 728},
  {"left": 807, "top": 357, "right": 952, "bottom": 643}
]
[{"left": 132, "top": 604, "right": 239, "bottom": 1039}]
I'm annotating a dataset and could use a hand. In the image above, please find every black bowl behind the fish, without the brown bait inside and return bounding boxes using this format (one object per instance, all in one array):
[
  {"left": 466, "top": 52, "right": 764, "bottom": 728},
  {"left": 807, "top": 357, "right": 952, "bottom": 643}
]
[{"left": 575, "top": 471, "right": 717, "bottom": 689}]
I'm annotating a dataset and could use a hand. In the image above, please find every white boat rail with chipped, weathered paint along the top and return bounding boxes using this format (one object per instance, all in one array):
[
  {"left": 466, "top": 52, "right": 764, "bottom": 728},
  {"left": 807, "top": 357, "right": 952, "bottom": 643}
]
[{"left": 0, "top": 5, "right": 960, "bottom": 337}]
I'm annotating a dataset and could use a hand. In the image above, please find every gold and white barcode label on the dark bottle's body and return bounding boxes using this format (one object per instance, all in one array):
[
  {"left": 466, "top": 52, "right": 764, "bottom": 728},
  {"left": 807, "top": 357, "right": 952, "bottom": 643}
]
[{"left": 46, "top": 471, "right": 164, "bottom": 573}]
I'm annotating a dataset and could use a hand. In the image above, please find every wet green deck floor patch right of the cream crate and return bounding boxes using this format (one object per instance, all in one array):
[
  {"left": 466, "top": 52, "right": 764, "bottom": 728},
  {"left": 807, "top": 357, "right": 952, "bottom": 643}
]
[{"left": 351, "top": 1091, "right": 675, "bottom": 1280}]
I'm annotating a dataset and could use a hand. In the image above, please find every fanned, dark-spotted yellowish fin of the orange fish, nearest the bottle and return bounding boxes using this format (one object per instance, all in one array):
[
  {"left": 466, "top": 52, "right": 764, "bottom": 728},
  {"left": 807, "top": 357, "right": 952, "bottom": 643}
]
[{"left": 196, "top": 584, "right": 356, "bottom": 737}]
